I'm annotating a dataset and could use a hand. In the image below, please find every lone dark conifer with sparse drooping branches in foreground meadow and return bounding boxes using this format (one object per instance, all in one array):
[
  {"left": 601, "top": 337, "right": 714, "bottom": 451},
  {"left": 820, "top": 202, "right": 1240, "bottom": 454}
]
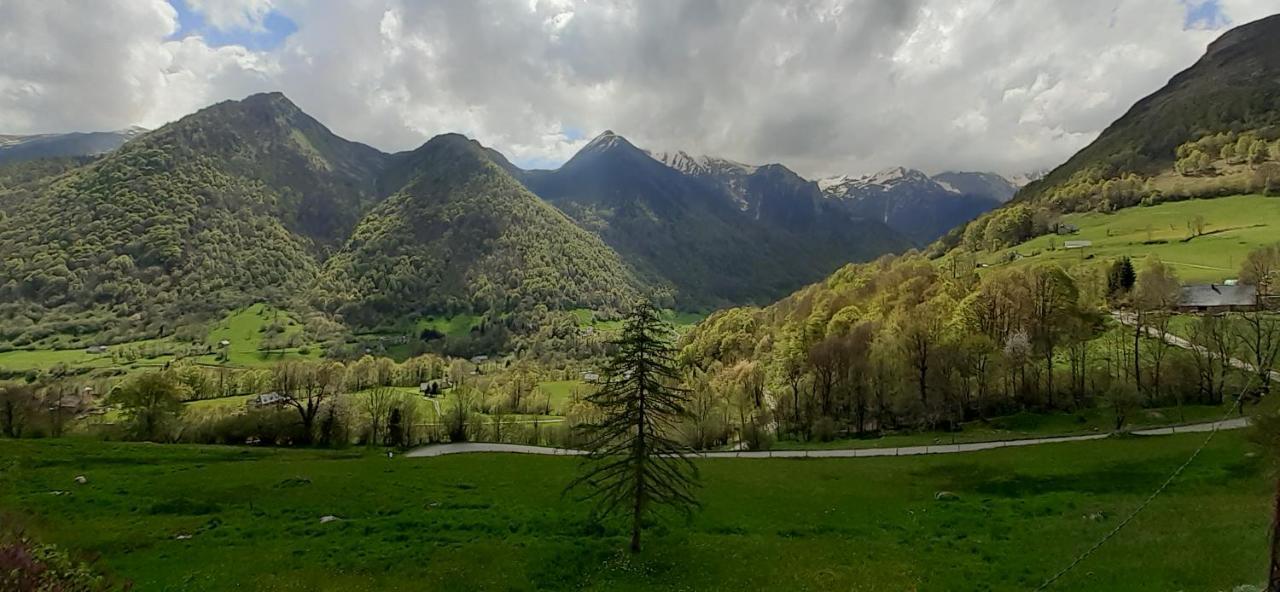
[{"left": 570, "top": 302, "right": 698, "bottom": 552}]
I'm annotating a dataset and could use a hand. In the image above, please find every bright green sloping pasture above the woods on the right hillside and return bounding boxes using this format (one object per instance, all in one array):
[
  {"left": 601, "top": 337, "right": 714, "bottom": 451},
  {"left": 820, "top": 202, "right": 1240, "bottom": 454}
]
[{"left": 979, "top": 195, "right": 1280, "bottom": 282}]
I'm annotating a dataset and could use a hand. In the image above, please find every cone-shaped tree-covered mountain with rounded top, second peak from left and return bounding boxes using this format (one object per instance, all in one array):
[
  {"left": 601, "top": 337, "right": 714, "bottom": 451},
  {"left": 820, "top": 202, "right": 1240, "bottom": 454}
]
[{"left": 324, "top": 135, "right": 639, "bottom": 325}]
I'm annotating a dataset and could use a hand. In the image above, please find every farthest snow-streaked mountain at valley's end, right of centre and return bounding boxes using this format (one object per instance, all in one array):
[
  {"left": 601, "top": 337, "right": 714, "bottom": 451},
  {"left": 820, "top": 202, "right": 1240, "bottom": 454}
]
[{"left": 818, "top": 167, "right": 1012, "bottom": 245}]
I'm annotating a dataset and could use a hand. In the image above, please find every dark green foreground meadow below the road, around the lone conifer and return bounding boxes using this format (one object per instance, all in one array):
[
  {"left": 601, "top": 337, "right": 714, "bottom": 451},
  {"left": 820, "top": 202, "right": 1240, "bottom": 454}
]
[{"left": 0, "top": 432, "right": 1272, "bottom": 592}]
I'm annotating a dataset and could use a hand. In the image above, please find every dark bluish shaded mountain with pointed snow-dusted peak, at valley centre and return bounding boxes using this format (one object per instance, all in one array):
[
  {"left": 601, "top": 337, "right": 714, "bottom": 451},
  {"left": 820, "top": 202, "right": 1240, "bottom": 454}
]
[{"left": 520, "top": 132, "right": 908, "bottom": 308}]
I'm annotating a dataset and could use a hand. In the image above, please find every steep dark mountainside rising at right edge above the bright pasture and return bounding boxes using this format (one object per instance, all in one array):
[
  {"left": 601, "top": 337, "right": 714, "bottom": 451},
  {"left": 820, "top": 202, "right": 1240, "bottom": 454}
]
[{"left": 934, "top": 15, "right": 1280, "bottom": 252}]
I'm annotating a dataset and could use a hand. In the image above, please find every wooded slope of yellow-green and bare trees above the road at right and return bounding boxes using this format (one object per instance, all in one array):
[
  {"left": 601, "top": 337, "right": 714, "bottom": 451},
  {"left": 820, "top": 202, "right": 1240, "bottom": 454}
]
[{"left": 681, "top": 246, "right": 1280, "bottom": 445}]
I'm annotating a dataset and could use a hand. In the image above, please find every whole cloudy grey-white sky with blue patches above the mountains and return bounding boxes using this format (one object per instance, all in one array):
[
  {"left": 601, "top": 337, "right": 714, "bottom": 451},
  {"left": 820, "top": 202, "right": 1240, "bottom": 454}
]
[{"left": 0, "top": 0, "right": 1277, "bottom": 177}]
